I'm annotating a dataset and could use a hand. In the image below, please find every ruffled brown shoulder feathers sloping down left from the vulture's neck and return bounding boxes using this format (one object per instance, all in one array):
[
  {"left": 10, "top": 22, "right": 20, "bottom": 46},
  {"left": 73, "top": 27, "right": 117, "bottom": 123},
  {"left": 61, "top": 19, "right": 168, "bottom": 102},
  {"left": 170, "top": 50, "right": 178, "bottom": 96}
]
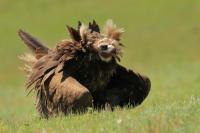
[{"left": 26, "top": 41, "right": 76, "bottom": 92}]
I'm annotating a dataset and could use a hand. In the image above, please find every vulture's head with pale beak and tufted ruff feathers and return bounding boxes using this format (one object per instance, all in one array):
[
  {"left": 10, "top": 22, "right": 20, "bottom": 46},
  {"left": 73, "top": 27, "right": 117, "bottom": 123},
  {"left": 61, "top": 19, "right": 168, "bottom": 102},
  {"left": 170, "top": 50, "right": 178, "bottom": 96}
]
[{"left": 68, "top": 20, "right": 123, "bottom": 62}]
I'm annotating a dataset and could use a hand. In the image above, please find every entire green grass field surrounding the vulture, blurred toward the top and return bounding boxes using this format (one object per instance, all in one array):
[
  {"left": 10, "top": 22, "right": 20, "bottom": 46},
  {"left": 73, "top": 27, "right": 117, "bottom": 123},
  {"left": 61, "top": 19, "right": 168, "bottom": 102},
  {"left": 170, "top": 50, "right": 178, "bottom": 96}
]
[{"left": 0, "top": 0, "right": 200, "bottom": 133}]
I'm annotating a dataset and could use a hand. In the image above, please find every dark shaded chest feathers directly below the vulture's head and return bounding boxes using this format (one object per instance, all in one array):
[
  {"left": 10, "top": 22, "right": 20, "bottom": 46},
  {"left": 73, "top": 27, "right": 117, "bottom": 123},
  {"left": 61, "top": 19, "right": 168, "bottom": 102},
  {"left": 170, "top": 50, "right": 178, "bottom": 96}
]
[{"left": 76, "top": 59, "right": 115, "bottom": 92}]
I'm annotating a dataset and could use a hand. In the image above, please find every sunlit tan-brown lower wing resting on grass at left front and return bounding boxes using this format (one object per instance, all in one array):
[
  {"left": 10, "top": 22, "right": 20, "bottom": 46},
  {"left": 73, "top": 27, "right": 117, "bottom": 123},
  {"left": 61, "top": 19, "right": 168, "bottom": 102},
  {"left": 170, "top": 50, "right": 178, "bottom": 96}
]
[{"left": 36, "top": 71, "right": 92, "bottom": 118}]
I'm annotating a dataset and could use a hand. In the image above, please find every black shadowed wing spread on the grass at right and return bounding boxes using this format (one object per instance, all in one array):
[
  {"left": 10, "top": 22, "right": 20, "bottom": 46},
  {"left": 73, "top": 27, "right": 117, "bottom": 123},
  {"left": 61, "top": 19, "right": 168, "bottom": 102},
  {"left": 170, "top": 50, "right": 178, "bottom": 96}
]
[{"left": 95, "top": 65, "right": 151, "bottom": 107}]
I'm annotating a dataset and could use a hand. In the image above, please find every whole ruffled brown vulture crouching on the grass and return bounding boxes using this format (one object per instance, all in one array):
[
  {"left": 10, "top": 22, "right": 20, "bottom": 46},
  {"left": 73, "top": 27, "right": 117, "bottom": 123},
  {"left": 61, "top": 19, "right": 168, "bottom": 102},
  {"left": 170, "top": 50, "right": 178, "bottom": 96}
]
[{"left": 18, "top": 20, "right": 151, "bottom": 118}]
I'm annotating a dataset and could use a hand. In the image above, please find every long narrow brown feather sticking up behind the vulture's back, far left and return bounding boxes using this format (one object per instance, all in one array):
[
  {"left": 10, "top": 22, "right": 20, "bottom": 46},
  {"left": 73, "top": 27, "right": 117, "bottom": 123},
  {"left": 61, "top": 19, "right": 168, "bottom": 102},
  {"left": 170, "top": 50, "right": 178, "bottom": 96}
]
[{"left": 18, "top": 29, "right": 49, "bottom": 54}]
